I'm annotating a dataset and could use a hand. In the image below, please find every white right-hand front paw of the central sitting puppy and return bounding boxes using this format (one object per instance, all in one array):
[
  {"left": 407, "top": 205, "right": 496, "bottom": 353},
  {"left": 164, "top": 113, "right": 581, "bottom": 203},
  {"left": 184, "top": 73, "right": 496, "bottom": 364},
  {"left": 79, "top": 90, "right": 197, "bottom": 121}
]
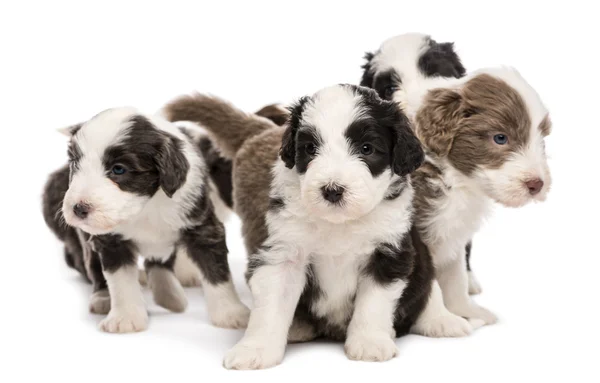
[{"left": 344, "top": 332, "right": 398, "bottom": 362}]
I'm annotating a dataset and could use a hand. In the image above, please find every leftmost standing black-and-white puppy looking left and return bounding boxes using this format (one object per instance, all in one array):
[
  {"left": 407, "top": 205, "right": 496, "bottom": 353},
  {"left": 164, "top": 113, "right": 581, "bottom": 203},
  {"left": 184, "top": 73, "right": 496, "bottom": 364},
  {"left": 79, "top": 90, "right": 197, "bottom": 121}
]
[{"left": 44, "top": 108, "right": 249, "bottom": 332}]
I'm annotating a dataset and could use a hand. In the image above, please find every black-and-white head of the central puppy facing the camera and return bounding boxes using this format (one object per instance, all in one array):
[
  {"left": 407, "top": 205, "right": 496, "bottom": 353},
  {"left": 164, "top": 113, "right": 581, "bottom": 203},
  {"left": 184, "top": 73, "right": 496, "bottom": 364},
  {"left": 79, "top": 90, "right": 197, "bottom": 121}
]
[{"left": 280, "top": 85, "right": 424, "bottom": 223}]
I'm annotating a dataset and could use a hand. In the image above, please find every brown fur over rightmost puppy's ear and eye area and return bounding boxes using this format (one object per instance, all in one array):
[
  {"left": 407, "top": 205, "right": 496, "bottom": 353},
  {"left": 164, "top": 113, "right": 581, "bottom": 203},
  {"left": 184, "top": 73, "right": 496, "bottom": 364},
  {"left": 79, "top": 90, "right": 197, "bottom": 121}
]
[{"left": 415, "top": 74, "right": 532, "bottom": 174}]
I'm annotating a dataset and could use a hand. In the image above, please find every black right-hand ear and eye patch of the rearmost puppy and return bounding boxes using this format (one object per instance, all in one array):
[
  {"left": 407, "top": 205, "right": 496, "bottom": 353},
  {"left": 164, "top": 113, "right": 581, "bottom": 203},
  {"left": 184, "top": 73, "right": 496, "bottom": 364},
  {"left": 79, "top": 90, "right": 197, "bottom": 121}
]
[{"left": 418, "top": 39, "right": 466, "bottom": 78}]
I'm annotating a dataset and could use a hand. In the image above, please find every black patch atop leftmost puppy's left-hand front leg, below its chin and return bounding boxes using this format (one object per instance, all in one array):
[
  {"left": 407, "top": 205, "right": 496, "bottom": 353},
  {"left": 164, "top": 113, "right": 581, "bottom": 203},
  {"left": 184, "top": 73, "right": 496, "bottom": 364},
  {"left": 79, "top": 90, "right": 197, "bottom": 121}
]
[{"left": 92, "top": 234, "right": 137, "bottom": 273}]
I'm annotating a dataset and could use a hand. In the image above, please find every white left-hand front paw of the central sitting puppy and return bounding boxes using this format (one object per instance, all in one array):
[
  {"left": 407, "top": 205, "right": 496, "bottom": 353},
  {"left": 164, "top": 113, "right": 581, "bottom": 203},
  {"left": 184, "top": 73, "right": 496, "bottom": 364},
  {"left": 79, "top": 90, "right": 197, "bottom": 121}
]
[{"left": 223, "top": 340, "right": 285, "bottom": 370}]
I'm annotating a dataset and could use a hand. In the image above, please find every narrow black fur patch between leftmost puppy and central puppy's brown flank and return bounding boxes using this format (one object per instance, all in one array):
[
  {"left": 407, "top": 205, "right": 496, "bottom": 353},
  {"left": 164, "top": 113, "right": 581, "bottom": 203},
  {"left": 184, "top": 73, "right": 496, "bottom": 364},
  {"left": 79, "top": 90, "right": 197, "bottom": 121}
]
[{"left": 198, "top": 137, "right": 233, "bottom": 208}]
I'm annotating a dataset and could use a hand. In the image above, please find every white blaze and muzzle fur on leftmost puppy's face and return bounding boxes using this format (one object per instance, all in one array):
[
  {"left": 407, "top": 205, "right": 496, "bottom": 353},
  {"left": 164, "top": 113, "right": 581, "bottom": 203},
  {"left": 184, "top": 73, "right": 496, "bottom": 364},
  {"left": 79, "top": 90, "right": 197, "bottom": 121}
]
[{"left": 63, "top": 108, "right": 148, "bottom": 234}]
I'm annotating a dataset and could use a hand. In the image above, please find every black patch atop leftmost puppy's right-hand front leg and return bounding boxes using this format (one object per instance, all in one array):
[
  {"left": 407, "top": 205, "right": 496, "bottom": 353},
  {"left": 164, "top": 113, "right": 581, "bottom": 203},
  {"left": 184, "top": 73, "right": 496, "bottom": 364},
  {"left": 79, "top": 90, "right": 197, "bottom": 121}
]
[{"left": 180, "top": 205, "right": 231, "bottom": 285}]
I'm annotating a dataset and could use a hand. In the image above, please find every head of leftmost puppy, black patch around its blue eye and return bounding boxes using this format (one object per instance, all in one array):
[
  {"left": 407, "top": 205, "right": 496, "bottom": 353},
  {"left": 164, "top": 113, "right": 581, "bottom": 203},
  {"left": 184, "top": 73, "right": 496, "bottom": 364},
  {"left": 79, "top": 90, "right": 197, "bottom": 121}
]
[{"left": 63, "top": 108, "right": 189, "bottom": 234}]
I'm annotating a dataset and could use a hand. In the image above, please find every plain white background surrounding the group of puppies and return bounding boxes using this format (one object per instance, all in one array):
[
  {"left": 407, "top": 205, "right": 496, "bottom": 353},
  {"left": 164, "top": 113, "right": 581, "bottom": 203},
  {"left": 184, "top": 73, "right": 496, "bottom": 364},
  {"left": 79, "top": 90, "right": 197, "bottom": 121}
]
[{"left": 0, "top": 0, "right": 600, "bottom": 382}]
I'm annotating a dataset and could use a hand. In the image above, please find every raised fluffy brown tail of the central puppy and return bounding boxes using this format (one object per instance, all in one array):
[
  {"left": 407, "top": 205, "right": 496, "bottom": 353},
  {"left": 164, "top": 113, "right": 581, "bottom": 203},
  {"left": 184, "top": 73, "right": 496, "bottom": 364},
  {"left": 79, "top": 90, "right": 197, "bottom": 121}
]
[{"left": 163, "top": 93, "right": 277, "bottom": 159}]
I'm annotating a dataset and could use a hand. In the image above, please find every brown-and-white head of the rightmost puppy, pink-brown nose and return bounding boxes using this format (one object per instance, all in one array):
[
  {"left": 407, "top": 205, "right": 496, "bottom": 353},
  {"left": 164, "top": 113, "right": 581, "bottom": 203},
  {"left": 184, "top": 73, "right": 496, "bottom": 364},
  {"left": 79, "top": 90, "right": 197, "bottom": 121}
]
[{"left": 416, "top": 68, "right": 551, "bottom": 207}]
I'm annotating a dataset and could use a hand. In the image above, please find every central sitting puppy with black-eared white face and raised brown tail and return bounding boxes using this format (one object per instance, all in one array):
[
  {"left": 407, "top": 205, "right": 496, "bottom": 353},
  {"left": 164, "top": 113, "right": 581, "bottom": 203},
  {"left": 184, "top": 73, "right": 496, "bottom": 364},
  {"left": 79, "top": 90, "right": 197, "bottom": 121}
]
[{"left": 165, "top": 85, "right": 470, "bottom": 369}]
